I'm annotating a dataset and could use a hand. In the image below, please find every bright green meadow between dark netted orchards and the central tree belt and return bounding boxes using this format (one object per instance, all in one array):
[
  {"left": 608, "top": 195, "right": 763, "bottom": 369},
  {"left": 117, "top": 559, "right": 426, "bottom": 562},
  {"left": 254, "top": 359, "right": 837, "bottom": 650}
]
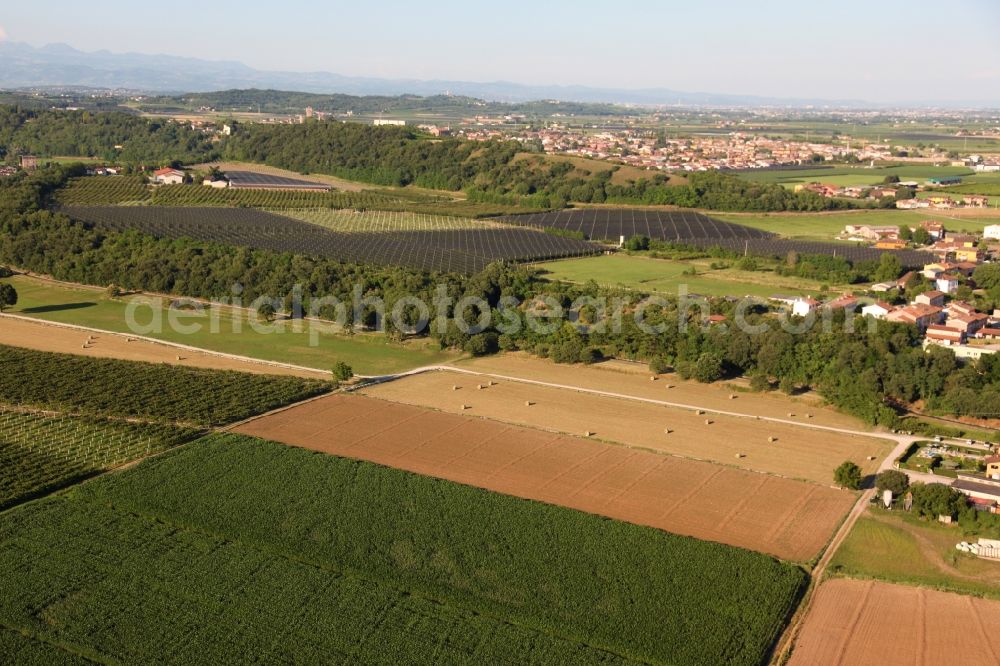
[{"left": 537, "top": 254, "right": 832, "bottom": 298}]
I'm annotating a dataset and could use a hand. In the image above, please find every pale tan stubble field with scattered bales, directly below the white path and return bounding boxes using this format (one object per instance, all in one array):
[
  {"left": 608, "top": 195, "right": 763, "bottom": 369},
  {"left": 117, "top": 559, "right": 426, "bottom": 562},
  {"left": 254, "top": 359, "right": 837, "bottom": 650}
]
[{"left": 364, "top": 372, "right": 892, "bottom": 486}]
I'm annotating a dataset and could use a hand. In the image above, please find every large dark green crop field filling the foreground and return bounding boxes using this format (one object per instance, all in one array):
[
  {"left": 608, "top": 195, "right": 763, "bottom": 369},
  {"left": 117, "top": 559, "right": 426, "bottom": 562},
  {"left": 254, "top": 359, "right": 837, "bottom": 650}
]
[{"left": 0, "top": 435, "right": 806, "bottom": 664}]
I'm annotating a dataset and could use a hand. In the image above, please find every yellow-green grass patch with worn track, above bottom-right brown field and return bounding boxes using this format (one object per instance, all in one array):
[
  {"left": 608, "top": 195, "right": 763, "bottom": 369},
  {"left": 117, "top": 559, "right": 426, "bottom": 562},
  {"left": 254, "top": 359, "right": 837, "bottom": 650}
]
[{"left": 830, "top": 509, "right": 1000, "bottom": 599}]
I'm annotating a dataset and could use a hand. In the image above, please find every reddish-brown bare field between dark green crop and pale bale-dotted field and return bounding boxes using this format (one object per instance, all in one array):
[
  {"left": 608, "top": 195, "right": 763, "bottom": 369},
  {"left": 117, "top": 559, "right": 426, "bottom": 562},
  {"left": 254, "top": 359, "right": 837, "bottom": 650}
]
[{"left": 235, "top": 394, "right": 855, "bottom": 562}]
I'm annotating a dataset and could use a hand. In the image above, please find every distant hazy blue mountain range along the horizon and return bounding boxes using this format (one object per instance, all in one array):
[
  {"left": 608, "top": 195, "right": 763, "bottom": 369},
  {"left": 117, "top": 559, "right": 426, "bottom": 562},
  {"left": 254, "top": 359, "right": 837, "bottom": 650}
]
[{"left": 0, "top": 41, "right": 888, "bottom": 107}]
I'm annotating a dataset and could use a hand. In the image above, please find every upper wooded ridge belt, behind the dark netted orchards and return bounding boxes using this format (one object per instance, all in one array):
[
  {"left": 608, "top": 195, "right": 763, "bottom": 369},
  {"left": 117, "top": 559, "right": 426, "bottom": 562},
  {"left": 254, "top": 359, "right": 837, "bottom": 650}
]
[{"left": 0, "top": 107, "right": 846, "bottom": 211}]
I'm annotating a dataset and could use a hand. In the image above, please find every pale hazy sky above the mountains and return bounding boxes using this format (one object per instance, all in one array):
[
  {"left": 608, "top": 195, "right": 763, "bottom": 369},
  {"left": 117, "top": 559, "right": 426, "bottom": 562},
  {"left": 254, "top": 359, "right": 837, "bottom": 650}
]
[{"left": 0, "top": 0, "right": 1000, "bottom": 102}]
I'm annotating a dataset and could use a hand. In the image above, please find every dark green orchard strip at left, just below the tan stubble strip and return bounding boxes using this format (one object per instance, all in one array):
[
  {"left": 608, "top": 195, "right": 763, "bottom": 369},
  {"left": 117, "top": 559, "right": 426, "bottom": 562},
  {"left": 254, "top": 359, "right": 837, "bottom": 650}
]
[{"left": 0, "top": 345, "right": 330, "bottom": 426}]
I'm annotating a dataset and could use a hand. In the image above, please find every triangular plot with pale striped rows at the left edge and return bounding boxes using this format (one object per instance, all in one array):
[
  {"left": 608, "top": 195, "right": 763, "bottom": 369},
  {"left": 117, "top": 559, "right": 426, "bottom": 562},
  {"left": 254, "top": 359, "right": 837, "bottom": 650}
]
[{"left": 0, "top": 406, "right": 197, "bottom": 509}]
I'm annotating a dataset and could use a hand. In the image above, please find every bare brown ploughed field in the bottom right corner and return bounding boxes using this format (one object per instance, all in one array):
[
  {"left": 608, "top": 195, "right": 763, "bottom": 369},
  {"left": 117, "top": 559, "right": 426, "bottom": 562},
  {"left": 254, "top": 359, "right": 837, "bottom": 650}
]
[{"left": 789, "top": 579, "right": 1000, "bottom": 666}]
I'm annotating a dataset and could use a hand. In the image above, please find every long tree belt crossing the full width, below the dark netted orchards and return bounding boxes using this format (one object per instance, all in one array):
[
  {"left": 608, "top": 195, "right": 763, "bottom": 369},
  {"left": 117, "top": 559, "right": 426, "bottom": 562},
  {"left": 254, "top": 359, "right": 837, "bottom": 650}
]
[{"left": 0, "top": 168, "right": 1000, "bottom": 425}]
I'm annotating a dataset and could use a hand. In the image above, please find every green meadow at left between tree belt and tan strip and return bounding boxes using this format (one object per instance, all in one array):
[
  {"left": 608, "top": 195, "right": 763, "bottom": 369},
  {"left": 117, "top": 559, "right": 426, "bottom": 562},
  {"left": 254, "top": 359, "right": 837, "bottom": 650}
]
[{"left": 2, "top": 276, "right": 456, "bottom": 375}]
